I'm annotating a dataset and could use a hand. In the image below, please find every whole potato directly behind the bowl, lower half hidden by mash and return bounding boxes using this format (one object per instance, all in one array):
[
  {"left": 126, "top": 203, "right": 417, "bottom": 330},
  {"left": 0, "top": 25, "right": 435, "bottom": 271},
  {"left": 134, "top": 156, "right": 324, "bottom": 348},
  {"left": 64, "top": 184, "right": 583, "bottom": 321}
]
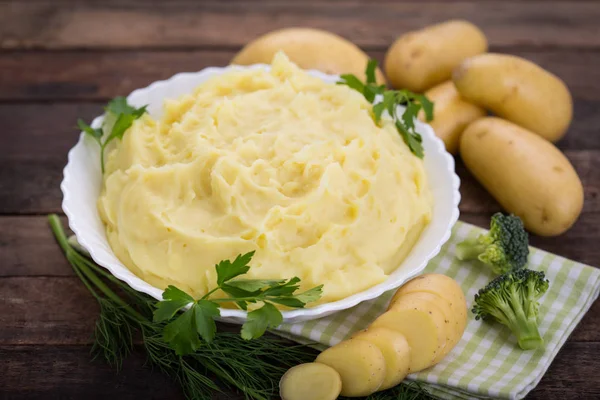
[{"left": 231, "top": 28, "right": 385, "bottom": 84}]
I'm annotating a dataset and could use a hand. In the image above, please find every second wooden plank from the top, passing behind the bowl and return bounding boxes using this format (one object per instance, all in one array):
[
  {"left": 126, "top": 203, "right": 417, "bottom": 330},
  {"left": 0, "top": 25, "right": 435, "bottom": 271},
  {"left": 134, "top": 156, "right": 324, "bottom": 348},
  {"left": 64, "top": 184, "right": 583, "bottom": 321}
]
[{"left": 0, "top": 48, "right": 600, "bottom": 101}]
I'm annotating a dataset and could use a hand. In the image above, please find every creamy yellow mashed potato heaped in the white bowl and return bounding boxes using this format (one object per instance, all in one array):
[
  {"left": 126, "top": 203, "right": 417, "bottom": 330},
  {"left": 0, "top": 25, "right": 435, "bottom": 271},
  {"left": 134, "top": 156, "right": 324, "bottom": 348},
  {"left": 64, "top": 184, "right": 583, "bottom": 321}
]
[{"left": 98, "top": 54, "right": 432, "bottom": 302}]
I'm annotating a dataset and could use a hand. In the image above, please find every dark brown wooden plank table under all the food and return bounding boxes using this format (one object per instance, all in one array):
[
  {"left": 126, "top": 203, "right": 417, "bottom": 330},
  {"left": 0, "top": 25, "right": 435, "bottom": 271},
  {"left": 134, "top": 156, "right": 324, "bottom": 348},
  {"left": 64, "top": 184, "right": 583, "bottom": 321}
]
[{"left": 0, "top": 0, "right": 600, "bottom": 399}]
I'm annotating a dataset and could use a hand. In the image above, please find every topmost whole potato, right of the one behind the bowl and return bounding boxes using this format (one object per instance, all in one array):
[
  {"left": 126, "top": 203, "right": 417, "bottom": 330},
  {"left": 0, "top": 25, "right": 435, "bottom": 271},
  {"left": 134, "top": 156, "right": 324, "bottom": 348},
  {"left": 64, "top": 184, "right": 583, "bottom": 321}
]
[{"left": 384, "top": 20, "right": 487, "bottom": 92}]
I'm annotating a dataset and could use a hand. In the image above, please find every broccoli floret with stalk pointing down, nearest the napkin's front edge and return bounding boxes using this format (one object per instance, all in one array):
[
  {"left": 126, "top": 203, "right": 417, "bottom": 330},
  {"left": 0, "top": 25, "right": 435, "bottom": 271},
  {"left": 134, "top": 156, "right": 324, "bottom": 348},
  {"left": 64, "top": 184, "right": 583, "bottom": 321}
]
[{"left": 473, "top": 269, "right": 548, "bottom": 350}]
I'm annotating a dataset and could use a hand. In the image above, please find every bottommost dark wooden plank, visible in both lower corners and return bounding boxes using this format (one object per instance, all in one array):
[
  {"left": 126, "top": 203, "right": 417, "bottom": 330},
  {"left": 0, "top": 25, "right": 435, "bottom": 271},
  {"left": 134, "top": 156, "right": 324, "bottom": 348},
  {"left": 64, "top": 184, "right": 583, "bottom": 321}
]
[{"left": 0, "top": 343, "right": 600, "bottom": 400}]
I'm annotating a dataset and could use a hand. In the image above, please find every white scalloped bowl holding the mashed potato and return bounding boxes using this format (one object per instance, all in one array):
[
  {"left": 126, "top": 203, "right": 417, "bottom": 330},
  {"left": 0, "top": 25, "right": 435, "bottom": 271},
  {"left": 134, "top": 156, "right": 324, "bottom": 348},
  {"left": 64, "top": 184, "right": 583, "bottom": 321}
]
[{"left": 61, "top": 65, "right": 460, "bottom": 323}]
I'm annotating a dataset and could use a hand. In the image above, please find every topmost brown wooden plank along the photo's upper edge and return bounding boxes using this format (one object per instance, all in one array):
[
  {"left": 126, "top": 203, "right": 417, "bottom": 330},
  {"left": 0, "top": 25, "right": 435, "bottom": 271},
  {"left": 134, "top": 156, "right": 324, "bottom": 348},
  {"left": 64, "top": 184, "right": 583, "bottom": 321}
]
[{"left": 0, "top": 0, "right": 600, "bottom": 49}]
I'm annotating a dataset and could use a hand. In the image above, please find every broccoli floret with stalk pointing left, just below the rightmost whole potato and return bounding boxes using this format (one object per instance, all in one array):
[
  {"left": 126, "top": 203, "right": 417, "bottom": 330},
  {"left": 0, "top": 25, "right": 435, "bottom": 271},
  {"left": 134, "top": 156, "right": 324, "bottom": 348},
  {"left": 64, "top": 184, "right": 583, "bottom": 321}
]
[{"left": 456, "top": 213, "right": 529, "bottom": 274}]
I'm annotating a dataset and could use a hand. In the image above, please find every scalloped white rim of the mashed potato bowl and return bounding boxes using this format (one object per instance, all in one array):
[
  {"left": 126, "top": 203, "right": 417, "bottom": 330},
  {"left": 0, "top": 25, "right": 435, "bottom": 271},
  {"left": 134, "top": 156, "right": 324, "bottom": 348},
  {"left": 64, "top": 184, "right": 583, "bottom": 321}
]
[{"left": 60, "top": 64, "right": 461, "bottom": 323}]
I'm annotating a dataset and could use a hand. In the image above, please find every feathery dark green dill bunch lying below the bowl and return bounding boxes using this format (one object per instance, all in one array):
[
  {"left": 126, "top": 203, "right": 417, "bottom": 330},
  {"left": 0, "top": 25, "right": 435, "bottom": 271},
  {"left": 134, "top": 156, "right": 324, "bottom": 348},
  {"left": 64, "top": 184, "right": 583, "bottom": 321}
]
[{"left": 49, "top": 215, "right": 431, "bottom": 400}]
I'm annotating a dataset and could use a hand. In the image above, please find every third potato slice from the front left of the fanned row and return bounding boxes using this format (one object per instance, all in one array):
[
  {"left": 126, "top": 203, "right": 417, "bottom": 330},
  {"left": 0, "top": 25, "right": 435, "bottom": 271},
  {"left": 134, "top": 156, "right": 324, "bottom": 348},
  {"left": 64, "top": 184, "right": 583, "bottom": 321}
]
[{"left": 352, "top": 328, "right": 410, "bottom": 390}]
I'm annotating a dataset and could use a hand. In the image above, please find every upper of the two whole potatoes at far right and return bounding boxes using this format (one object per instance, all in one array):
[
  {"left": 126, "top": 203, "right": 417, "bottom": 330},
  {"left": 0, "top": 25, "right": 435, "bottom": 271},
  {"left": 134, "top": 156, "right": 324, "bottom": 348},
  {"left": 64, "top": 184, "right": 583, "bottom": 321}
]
[{"left": 452, "top": 54, "right": 573, "bottom": 142}]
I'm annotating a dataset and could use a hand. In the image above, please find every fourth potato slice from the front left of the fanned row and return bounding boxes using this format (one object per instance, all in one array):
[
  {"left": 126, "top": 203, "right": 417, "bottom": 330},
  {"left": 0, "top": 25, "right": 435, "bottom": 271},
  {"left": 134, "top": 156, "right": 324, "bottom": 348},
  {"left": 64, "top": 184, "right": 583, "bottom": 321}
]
[{"left": 371, "top": 308, "right": 445, "bottom": 373}]
